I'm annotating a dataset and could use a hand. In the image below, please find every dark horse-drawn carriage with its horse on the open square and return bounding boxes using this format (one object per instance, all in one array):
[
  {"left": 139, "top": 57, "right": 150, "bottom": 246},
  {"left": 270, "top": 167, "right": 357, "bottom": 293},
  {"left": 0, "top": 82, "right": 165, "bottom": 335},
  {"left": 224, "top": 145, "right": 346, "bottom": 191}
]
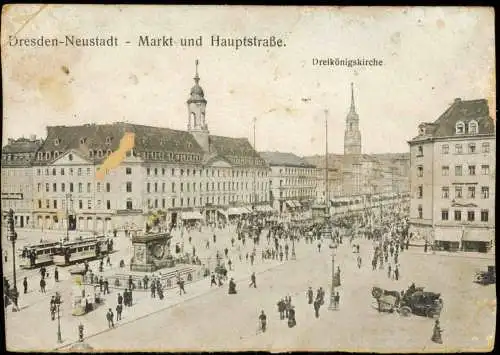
[{"left": 372, "top": 285, "right": 443, "bottom": 318}]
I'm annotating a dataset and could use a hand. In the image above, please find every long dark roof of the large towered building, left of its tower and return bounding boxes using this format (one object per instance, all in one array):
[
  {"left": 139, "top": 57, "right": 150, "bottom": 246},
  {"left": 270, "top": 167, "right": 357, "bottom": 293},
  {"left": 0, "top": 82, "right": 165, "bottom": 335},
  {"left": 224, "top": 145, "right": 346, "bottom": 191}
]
[{"left": 34, "top": 122, "right": 203, "bottom": 163}]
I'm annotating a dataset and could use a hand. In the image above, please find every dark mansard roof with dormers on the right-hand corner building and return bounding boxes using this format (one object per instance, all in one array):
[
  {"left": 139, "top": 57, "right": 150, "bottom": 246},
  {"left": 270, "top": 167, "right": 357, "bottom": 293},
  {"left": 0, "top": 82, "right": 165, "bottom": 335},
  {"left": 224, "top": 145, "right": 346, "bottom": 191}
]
[{"left": 413, "top": 98, "right": 495, "bottom": 140}]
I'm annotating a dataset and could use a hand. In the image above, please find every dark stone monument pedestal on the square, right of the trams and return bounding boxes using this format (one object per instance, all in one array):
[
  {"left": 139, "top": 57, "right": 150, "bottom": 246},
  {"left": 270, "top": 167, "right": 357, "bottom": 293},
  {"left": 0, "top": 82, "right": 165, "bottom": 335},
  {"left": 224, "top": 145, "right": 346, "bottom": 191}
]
[{"left": 130, "top": 232, "right": 174, "bottom": 272}]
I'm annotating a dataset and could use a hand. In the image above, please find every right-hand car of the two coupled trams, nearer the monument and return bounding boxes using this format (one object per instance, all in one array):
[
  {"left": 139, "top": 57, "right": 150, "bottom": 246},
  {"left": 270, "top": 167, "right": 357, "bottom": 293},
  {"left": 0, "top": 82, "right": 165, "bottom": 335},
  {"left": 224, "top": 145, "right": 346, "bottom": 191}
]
[{"left": 53, "top": 237, "right": 113, "bottom": 266}]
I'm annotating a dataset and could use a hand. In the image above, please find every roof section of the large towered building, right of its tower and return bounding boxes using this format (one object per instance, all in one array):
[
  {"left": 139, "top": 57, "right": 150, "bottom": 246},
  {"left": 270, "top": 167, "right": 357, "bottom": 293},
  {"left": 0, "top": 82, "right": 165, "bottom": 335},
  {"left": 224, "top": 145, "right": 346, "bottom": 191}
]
[{"left": 208, "top": 135, "right": 267, "bottom": 166}]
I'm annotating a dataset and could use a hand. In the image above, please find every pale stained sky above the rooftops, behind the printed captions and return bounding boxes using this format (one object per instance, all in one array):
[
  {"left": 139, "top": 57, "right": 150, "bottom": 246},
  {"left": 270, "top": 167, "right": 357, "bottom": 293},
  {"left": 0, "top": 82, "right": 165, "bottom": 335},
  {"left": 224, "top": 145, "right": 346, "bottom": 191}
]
[{"left": 1, "top": 5, "right": 496, "bottom": 155}]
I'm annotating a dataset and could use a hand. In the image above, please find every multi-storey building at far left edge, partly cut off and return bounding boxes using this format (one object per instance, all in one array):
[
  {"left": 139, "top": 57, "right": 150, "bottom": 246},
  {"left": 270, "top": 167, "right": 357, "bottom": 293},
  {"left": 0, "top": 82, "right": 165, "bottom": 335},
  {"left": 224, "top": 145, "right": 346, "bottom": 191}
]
[{"left": 2, "top": 136, "right": 42, "bottom": 228}]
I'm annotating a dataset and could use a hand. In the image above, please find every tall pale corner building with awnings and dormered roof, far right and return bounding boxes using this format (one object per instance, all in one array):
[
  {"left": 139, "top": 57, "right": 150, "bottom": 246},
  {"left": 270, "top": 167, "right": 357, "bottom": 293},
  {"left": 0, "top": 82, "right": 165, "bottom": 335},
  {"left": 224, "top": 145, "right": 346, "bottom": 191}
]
[{"left": 409, "top": 99, "right": 496, "bottom": 251}]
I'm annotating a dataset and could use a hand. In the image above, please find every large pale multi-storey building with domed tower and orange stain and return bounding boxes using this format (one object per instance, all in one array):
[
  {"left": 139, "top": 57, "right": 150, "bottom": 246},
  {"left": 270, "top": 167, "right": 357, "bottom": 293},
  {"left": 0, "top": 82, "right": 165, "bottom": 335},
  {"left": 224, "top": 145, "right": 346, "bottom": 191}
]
[{"left": 7, "top": 60, "right": 269, "bottom": 233}]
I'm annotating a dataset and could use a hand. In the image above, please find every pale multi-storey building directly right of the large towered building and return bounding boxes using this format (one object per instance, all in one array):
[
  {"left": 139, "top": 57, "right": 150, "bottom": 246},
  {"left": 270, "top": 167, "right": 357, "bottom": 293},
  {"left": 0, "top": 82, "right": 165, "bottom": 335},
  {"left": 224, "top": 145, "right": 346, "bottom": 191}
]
[{"left": 260, "top": 152, "right": 316, "bottom": 213}]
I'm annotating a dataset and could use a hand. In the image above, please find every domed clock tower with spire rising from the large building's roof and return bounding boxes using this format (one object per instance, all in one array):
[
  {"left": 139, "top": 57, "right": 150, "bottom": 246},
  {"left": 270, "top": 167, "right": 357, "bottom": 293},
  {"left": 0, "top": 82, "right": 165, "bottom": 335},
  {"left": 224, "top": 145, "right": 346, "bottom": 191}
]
[{"left": 187, "top": 59, "right": 210, "bottom": 152}]
